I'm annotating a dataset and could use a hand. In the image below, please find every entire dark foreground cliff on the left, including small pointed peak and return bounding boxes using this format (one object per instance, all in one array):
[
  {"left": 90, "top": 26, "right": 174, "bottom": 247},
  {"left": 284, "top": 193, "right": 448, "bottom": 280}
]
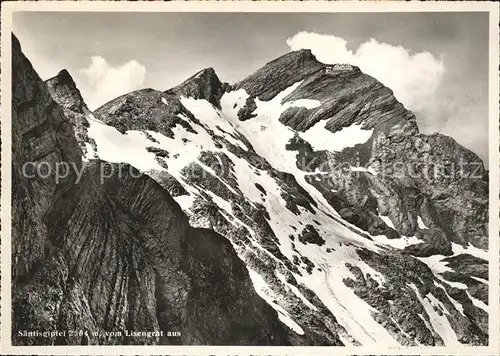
[{"left": 12, "top": 34, "right": 289, "bottom": 345}]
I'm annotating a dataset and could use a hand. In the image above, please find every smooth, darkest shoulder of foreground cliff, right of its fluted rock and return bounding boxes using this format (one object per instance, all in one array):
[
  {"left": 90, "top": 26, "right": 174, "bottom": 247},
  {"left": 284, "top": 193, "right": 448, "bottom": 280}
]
[{"left": 185, "top": 229, "right": 288, "bottom": 345}]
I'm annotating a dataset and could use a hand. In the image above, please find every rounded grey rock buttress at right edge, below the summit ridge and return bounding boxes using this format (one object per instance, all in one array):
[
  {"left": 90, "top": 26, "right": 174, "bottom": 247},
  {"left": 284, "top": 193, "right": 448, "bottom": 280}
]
[{"left": 371, "top": 126, "right": 488, "bottom": 250}]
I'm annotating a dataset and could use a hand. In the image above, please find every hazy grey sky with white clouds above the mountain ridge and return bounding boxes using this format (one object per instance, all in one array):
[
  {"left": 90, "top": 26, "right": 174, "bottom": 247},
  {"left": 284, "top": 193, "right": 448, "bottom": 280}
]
[{"left": 13, "top": 12, "right": 488, "bottom": 160}]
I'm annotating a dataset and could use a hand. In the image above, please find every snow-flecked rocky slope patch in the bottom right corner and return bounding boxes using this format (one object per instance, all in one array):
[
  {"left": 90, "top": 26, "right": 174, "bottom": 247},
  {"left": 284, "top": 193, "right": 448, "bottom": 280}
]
[{"left": 344, "top": 250, "right": 488, "bottom": 345}]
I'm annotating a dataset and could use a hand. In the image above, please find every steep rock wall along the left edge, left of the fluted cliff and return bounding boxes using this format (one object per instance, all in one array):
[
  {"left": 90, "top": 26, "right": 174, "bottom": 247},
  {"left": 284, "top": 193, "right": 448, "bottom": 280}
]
[{"left": 12, "top": 33, "right": 82, "bottom": 278}]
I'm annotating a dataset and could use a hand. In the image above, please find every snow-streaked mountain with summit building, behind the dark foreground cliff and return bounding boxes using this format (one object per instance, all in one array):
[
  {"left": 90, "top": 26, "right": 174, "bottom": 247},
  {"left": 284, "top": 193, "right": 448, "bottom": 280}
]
[{"left": 46, "top": 51, "right": 488, "bottom": 345}]
